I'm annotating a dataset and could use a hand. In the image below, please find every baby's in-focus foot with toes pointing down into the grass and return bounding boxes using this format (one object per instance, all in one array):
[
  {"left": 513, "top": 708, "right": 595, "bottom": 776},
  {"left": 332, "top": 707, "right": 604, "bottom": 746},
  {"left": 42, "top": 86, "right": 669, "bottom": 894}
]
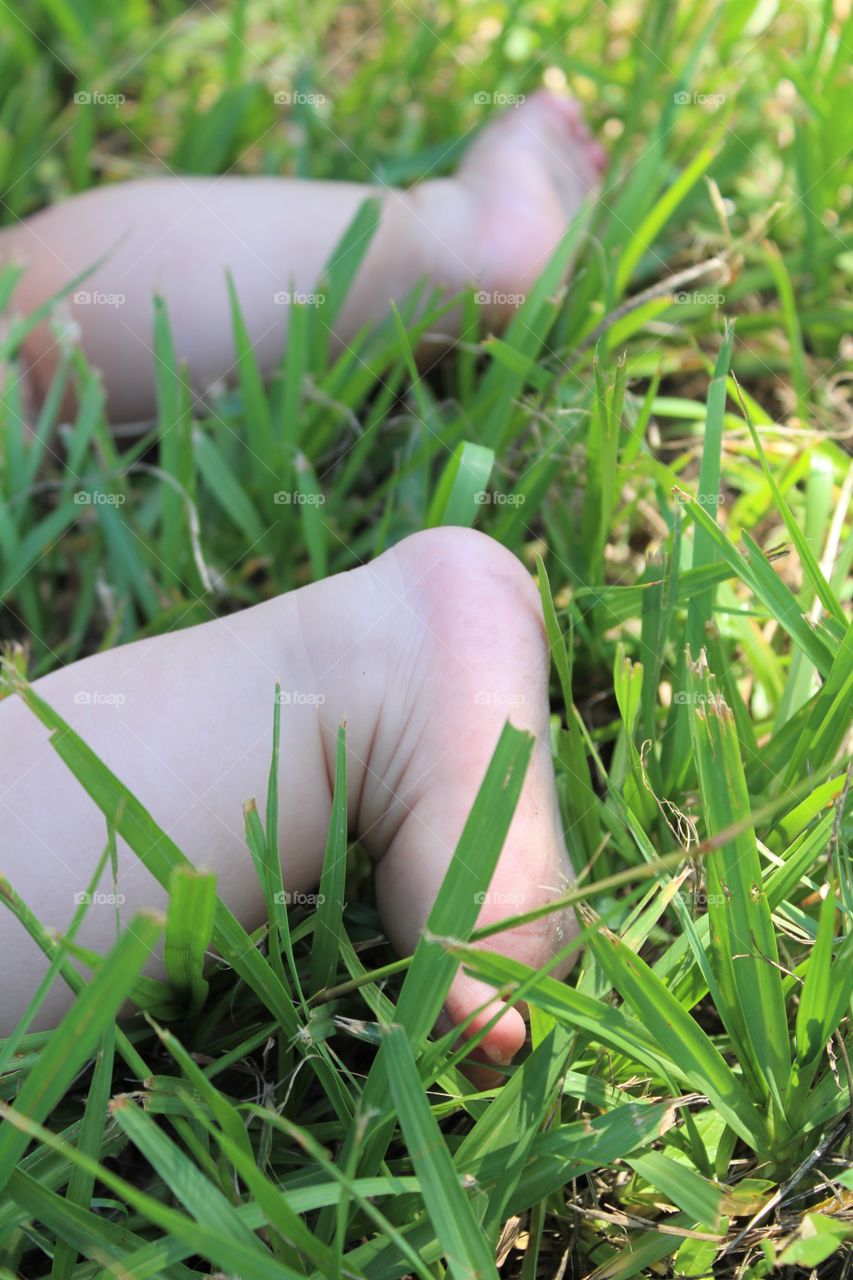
[{"left": 338, "top": 529, "right": 575, "bottom": 1062}]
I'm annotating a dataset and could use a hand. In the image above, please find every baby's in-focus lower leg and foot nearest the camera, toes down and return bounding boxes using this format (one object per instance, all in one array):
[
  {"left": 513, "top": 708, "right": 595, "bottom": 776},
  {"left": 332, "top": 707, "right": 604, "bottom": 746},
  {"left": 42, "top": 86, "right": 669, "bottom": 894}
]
[{"left": 0, "top": 529, "right": 574, "bottom": 1061}]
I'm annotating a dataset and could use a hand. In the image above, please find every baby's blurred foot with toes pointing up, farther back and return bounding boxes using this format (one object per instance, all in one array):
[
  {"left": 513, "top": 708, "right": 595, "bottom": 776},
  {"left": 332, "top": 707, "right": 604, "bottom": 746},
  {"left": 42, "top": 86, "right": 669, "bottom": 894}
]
[{"left": 456, "top": 90, "right": 606, "bottom": 321}]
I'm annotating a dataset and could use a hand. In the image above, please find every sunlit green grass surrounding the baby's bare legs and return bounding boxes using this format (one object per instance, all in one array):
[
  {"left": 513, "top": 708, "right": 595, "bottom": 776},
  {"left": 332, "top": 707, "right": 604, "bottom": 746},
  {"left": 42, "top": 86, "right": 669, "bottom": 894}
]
[{"left": 0, "top": 0, "right": 853, "bottom": 1280}]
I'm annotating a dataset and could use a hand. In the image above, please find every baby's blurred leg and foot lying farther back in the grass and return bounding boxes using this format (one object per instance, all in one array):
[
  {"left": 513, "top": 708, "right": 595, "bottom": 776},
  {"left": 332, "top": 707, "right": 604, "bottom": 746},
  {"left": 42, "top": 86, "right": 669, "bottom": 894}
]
[{"left": 0, "top": 92, "right": 605, "bottom": 422}]
